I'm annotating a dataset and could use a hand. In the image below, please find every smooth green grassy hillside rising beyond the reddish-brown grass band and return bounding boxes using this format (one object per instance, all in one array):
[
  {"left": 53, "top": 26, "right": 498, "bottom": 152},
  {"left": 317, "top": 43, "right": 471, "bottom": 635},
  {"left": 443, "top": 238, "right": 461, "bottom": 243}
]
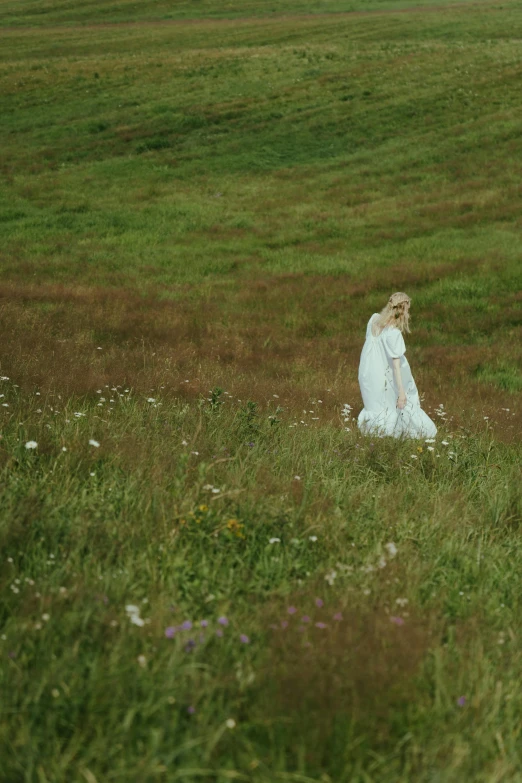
[{"left": 1, "top": 4, "right": 521, "bottom": 295}]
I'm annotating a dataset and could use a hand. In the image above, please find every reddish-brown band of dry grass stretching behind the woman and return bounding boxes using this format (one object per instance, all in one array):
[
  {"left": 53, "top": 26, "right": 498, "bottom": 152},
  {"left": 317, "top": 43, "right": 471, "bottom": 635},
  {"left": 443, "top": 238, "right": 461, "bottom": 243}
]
[{"left": 0, "top": 272, "right": 520, "bottom": 437}]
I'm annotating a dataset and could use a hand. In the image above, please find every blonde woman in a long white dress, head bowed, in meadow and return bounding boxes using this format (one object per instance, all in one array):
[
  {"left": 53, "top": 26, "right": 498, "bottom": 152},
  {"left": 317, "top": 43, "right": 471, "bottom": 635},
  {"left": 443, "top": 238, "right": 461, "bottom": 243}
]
[{"left": 357, "top": 292, "right": 437, "bottom": 438}]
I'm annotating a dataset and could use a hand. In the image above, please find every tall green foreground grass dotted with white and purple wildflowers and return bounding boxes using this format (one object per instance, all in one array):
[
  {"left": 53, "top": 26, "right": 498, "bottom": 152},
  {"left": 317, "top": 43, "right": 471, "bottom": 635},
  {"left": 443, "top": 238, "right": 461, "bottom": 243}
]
[{"left": 2, "top": 379, "right": 522, "bottom": 781}]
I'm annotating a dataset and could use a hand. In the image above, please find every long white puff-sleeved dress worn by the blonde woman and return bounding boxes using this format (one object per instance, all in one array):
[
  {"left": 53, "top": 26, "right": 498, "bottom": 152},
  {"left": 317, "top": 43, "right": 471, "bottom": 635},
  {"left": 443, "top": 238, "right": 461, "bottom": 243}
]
[{"left": 357, "top": 313, "right": 437, "bottom": 438}]
